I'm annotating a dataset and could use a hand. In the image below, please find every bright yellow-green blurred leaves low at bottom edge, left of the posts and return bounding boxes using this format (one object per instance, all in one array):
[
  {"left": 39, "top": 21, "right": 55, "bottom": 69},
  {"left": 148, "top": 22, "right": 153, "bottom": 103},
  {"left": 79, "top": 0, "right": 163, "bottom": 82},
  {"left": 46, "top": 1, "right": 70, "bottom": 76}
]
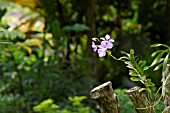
[{"left": 33, "top": 96, "right": 93, "bottom": 113}]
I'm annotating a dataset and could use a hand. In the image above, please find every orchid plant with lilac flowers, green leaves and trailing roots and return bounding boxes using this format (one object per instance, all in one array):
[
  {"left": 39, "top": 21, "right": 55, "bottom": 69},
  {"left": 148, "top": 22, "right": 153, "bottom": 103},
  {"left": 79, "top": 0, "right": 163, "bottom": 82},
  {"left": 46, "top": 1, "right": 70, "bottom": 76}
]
[{"left": 92, "top": 34, "right": 170, "bottom": 110}]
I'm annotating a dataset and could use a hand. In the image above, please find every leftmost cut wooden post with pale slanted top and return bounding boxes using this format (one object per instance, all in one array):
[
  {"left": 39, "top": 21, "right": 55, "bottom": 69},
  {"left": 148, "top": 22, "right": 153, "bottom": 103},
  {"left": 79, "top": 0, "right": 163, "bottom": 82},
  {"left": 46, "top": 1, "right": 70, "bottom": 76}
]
[{"left": 90, "top": 81, "right": 120, "bottom": 113}]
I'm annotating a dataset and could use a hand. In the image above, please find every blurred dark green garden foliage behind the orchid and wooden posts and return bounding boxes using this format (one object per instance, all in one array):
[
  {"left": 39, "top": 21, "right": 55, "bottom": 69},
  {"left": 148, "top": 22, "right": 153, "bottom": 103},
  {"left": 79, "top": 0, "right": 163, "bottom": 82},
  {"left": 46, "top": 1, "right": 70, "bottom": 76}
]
[{"left": 0, "top": 0, "right": 170, "bottom": 113}]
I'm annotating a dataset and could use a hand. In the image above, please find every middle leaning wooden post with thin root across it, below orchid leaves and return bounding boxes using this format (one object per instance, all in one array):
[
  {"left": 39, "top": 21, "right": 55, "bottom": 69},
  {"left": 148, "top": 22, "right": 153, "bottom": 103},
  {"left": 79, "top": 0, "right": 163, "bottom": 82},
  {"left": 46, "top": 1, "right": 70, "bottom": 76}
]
[{"left": 126, "top": 86, "right": 155, "bottom": 113}]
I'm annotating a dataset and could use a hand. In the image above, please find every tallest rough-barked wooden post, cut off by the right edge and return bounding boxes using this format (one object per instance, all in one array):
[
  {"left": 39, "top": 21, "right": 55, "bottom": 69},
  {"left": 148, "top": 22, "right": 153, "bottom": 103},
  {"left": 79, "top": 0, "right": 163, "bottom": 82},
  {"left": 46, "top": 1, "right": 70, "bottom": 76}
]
[{"left": 162, "top": 64, "right": 170, "bottom": 113}]
